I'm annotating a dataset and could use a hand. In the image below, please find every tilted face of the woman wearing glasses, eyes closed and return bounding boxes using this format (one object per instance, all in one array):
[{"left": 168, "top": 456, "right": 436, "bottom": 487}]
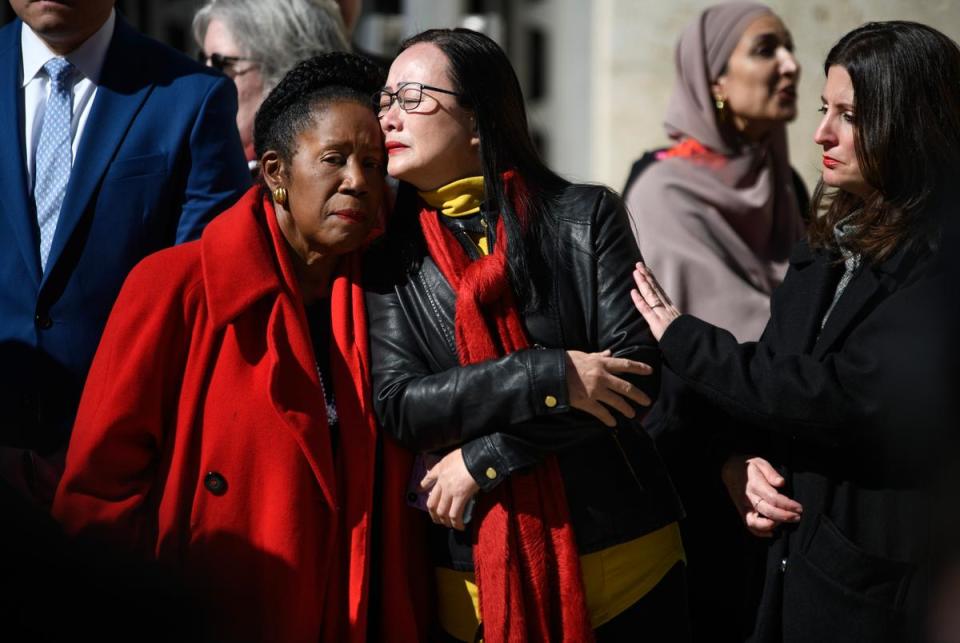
[{"left": 380, "top": 43, "right": 482, "bottom": 190}]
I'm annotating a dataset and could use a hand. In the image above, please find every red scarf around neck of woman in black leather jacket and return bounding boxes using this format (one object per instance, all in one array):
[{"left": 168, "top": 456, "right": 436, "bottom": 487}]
[{"left": 420, "top": 172, "right": 593, "bottom": 643}]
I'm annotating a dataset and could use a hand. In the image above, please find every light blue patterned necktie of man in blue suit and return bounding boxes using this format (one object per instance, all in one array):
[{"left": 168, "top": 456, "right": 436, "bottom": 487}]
[{"left": 33, "top": 58, "right": 74, "bottom": 271}]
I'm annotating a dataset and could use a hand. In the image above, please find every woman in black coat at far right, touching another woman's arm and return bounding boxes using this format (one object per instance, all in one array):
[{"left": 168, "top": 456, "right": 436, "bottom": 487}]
[{"left": 633, "top": 22, "right": 960, "bottom": 642}]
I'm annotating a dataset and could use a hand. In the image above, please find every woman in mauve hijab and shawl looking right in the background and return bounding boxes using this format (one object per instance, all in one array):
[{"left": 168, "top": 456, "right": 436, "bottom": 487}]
[{"left": 624, "top": 2, "right": 806, "bottom": 640}]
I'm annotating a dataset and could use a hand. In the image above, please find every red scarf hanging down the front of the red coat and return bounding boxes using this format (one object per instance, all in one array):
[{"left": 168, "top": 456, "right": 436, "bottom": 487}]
[{"left": 263, "top": 198, "right": 429, "bottom": 643}]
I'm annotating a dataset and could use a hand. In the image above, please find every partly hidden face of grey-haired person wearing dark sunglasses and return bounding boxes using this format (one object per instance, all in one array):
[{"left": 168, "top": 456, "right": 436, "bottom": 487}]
[{"left": 203, "top": 18, "right": 264, "bottom": 160}]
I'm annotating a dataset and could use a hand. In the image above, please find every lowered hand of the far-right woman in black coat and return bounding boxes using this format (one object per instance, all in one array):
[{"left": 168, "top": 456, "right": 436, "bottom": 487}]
[{"left": 720, "top": 455, "right": 803, "bottom": 538}]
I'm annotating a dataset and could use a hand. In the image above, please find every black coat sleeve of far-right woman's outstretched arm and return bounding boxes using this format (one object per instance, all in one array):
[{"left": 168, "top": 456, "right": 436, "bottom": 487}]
[{"left": 660, "top": 266, "right": 945, "bottom": 463}]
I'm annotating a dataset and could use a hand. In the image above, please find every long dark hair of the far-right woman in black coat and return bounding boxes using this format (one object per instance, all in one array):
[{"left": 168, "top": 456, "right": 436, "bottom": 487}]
[{"left": 809, "top": 21, "right": 960, "bottom": 262}]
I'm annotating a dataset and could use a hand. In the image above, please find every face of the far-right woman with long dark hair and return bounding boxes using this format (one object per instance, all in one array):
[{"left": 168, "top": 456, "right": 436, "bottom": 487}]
[{"left": 813, "top": 65, "right": 872, "bottom": 197}]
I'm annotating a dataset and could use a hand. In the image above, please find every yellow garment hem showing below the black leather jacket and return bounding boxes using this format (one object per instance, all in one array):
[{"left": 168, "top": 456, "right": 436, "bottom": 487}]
[{"left": 434, "top": 522, "right": 686, "bottom": 641}]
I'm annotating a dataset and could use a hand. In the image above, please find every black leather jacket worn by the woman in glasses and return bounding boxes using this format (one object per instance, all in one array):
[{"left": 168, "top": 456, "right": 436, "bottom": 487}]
[{"left": 365, "top": 185, "right": 682, "bottom": 567}]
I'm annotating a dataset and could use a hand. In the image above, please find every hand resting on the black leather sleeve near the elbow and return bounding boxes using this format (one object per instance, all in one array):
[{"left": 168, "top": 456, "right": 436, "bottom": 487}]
[{"left": 567, "top": 350, "right": 653, "bottom": 426}]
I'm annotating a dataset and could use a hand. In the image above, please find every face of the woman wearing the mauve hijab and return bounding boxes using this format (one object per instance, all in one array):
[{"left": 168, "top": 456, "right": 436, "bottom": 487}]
[{"left": 712, "top": 15, "right": 800, "bottom": 140}]
